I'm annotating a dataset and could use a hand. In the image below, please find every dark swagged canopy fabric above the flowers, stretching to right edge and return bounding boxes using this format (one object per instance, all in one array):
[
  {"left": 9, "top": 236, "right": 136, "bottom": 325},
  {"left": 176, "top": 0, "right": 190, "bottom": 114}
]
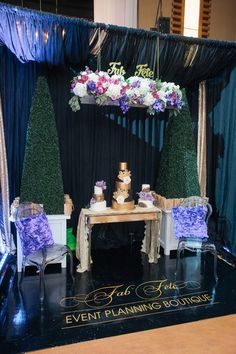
[{"left": 90, "top": 25, "right": 236, "bottom": 87}]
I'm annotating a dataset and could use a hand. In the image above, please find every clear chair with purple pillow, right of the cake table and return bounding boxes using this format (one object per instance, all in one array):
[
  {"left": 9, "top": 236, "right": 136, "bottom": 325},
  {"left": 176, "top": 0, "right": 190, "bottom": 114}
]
[{"left": 172, "top": 196, "right": 218, "bottom": 282}]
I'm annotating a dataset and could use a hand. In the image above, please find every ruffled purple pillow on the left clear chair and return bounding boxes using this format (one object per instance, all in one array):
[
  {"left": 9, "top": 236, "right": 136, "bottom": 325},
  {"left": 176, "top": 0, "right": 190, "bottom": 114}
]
[{"left": 15, "top": 213, "right": 54, "bottom": 256}]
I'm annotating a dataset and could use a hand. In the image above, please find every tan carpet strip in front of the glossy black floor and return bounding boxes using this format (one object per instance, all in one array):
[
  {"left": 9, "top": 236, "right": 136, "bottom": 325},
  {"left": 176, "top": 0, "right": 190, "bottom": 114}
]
[{"left": 30, "top": 315, "right": 236, "bottom": 354}]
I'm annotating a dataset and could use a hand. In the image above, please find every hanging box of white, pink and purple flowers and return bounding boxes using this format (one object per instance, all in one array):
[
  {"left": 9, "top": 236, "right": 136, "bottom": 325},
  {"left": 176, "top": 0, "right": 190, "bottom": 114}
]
[{"left": 69, "top": 67, "right": 183, "bottom": 114}]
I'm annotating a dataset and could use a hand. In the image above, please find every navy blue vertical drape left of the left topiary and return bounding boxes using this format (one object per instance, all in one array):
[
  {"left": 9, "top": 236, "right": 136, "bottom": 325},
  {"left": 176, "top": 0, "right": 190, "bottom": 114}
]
[{"left": 0, "top": 47, "right": 36, "bottom": 202}]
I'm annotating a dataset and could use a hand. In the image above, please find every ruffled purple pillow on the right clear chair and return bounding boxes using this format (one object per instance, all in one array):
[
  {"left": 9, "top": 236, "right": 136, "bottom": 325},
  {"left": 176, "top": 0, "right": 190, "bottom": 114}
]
[{"left": 172, "top": 205, "right": 208, "bottom": 240}]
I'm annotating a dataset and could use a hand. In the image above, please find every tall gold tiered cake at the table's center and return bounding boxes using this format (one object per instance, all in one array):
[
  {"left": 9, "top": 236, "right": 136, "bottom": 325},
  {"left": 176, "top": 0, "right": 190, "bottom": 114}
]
[{"left": 111, "top": 162, "right": 134, "bottom": 210}]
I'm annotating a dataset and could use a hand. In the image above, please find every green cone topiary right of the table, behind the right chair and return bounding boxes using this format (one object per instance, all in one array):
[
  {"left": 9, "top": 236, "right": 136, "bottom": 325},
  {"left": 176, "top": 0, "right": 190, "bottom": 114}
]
[{"left": 155, "top": 90, "right": 200, "bottom": 198}]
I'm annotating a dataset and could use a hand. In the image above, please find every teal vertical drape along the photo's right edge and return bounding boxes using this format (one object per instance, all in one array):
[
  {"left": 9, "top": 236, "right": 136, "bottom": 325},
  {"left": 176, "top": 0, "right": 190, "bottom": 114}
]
[{"left": 207, "top": 68, "right": 236, "bottom": 255}]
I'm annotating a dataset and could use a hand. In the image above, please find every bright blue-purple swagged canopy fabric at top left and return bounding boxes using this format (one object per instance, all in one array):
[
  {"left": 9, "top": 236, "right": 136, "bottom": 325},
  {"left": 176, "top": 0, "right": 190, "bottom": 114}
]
[{"left": 0, "top": 4, "right": 89, "bottom": 65}]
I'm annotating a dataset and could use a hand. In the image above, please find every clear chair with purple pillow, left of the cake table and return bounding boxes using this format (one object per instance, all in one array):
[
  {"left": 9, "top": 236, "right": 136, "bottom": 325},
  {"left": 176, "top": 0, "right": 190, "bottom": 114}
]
[{"left": 15, "top": 203, "right": 74, "bottom": 301}]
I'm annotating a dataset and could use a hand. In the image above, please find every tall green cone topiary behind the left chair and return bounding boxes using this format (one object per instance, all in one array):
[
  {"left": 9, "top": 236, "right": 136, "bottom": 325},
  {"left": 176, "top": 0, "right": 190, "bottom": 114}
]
[{"left": 20, "top": 77, "right": 64, "bottom": 214}]
